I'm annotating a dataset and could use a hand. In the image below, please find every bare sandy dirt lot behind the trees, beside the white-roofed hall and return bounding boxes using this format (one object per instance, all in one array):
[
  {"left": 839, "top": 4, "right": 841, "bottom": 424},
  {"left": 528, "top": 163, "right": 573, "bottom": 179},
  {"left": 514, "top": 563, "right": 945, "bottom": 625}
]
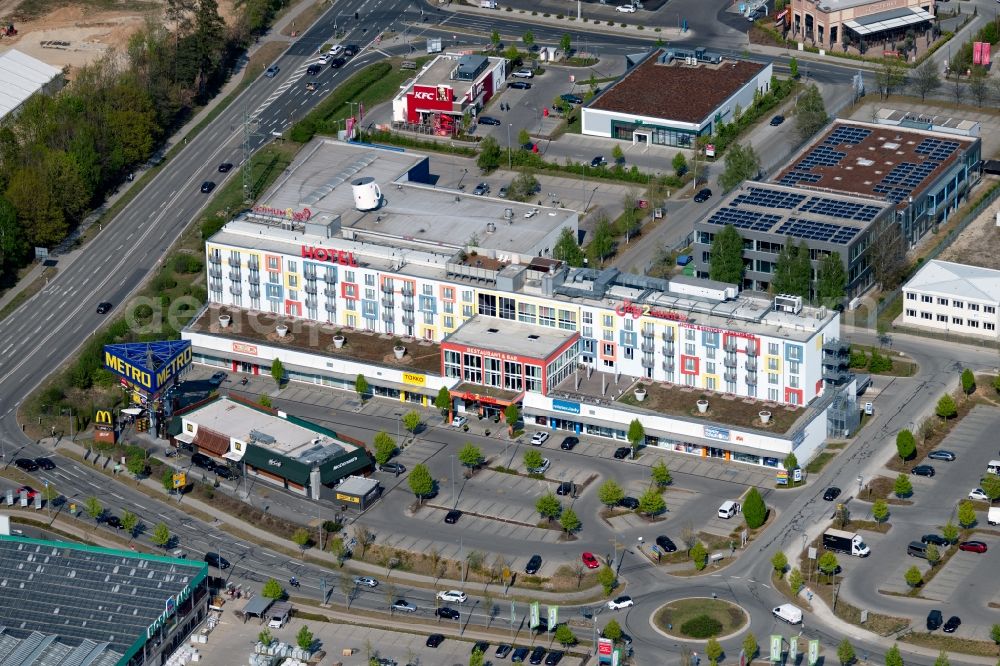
[{"left": 0, "top": 0, "right": 233, "bottom": 70}]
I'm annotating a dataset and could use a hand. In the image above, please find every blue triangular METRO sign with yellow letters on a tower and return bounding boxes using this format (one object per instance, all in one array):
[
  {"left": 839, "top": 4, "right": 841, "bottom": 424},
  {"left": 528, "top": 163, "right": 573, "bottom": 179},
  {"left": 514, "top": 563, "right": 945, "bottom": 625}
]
[{"left": 104, "top": 340, "right": 191, "bottom": 394}]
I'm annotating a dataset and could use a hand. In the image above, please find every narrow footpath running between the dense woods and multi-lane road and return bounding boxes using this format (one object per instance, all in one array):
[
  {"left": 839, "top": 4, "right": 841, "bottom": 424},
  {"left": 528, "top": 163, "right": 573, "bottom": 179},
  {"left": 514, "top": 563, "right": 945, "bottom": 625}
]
[{"left": 0, "top": 0, "right": 310, "bottom": 310}]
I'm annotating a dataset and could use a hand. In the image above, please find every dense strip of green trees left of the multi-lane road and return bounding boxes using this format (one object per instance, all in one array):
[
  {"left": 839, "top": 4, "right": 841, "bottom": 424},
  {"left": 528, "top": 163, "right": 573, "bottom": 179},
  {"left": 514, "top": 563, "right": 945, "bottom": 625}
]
[{"left": 0, "top": 0, "right": 285, "bottom": 277}]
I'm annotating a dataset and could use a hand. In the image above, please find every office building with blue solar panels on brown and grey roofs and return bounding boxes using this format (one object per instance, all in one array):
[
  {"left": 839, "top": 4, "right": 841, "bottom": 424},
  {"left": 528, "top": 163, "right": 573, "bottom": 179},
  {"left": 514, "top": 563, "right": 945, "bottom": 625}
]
[{"left": 694, "top": 118, "right": 981, "bottom": 298}]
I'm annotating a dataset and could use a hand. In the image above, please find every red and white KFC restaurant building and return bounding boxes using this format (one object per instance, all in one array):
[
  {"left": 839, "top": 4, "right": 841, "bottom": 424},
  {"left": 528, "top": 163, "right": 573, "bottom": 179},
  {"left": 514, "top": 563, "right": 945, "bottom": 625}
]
[{"left": 392, "top": 54, "right": 507, "bottom": 134}]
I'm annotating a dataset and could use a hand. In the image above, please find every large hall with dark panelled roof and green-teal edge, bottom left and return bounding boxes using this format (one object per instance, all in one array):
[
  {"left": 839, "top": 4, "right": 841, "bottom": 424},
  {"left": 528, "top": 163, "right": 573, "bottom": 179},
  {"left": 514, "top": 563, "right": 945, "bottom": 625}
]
[{"left": 0, "top": 535, "right": 209, "bottom": 666}]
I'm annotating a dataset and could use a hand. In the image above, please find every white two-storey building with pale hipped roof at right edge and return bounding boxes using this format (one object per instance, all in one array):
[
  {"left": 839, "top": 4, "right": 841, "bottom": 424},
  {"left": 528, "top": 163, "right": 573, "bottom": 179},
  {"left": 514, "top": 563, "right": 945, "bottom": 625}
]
[{"left": 902, "top": 259, "right": 1000, "bottom": 338}]
